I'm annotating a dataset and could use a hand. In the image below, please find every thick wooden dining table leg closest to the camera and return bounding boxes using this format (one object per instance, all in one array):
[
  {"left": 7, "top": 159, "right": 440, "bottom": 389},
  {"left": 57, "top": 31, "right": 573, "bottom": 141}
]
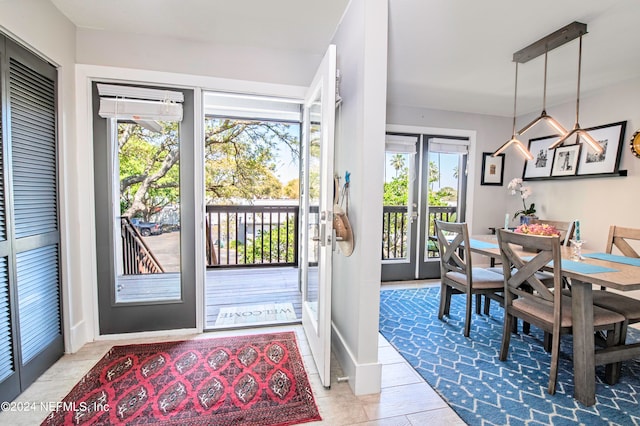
[{"left": 571, "top": 280, "right": 596, "bottom": 406}]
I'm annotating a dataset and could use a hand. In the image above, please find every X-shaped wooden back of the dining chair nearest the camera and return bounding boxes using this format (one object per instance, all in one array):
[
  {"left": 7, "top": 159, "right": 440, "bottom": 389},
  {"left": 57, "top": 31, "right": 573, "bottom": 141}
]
[{"left": 498, "top": 229, "right": 562, "bottom": 316}]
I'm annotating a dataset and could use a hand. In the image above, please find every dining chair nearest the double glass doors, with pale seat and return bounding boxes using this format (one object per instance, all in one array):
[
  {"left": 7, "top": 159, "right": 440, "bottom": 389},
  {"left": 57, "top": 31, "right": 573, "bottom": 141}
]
[{"left": 435, "top": 220, "right": 504, "bottom": 337}]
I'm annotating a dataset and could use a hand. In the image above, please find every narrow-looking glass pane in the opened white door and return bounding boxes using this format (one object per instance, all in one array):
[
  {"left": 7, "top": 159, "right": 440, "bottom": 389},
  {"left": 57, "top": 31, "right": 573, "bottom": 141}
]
[{"left": 304, "top": 97, "right": 322, "bottom": 322}]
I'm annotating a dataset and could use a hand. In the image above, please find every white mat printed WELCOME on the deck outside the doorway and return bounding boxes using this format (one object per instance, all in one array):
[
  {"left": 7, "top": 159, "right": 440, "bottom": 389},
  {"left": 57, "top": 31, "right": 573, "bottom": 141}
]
[{"left": 215, "top": 303, "right": 297, "bottom": 327}]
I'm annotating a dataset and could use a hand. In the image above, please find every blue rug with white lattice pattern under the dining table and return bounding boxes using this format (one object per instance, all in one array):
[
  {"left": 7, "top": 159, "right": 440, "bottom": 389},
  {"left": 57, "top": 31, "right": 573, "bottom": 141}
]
[{"left": 380, "top": 286, "right": 640, "bottom": 426}]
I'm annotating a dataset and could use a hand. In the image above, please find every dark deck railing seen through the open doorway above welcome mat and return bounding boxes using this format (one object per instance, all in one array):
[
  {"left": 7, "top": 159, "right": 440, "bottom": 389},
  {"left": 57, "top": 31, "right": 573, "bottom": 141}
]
[{"left": 206, "top": 205, "right": 300, "bottom": 268}]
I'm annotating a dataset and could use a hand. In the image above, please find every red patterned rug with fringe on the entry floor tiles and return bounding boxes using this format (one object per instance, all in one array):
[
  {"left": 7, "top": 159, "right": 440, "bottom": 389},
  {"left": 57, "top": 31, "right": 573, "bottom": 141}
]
[{"left": 42, "top": 332, "right": 321, "bottom": 426}]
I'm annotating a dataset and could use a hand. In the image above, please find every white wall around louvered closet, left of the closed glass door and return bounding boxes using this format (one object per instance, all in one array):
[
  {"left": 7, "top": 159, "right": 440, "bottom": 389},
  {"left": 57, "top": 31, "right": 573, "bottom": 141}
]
[{"left": 0, "top": 0, "right": 91, "bottom": 352}]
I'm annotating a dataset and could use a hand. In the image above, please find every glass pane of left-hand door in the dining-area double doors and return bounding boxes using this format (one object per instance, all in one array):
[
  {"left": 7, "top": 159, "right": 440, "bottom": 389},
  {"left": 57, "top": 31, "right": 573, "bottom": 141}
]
[{"left": 382, "top": 151, "right": 414, "bottom": 260}]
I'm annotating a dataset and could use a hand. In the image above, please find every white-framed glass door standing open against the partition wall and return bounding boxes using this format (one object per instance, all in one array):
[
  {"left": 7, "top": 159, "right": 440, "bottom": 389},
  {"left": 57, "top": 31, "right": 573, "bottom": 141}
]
[{"left": 300, "top": 45, "right": 336, "bottom": 387}]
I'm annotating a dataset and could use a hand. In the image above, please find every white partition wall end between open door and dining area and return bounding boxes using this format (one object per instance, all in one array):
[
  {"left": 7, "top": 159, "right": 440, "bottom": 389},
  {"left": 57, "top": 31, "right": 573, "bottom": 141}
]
[{"left": 332, "top": 0, "right": 388, "bottom": 395}]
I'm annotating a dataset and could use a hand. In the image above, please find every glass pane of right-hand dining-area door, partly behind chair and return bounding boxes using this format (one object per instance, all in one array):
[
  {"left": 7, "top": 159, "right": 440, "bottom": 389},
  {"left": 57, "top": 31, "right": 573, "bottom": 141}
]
[{"left": 424, "top": 152, "right": 463, "bottom": 260}]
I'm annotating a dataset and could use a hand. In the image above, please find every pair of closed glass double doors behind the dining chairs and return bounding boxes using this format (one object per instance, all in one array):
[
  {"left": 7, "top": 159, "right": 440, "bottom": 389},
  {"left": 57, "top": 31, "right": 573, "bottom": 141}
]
[{"left": 382, "top": 134, "right": 469, "bottom": 281}]
